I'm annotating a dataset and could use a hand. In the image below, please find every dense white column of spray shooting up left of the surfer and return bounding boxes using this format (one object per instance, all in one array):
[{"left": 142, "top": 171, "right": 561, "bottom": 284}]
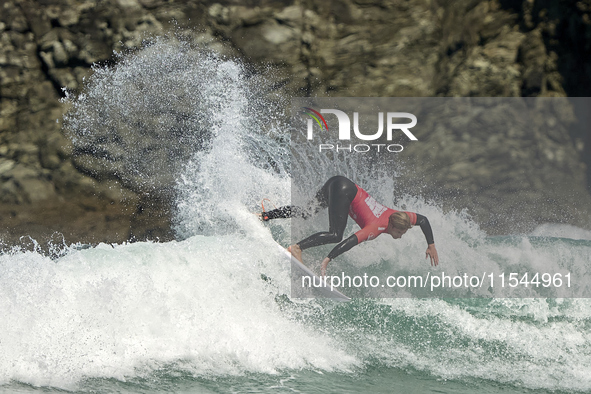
[{"left": 170, "top": 55, "right": 290, "bottom": 237}]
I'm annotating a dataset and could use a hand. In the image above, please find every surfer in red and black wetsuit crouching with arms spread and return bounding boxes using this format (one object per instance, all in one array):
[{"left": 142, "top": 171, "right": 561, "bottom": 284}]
[{"left": 261, "top": 176, "right": 439, "bottom": 276}]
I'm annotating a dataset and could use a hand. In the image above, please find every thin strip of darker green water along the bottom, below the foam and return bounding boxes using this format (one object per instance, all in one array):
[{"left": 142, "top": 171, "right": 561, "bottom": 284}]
[{"left": 1, "top": 368, "right": 568, "bottom": 394}]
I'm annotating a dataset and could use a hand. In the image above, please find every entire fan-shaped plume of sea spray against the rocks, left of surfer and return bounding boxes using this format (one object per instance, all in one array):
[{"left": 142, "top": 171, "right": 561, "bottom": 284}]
[{"left": 64, "top": 35, "right": 289, "bottom": 238}]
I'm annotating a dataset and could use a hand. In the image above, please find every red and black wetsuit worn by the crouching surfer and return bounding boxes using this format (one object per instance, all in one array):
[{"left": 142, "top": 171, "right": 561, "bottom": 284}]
[{"left": 263, "top": 176, "right": 434, "bottom": 260}]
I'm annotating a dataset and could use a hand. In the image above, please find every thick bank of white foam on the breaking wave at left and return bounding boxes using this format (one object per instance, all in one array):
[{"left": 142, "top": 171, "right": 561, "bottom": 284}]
[{"left": 0, "top": 232, "right": 357, "bottom": 387}]
